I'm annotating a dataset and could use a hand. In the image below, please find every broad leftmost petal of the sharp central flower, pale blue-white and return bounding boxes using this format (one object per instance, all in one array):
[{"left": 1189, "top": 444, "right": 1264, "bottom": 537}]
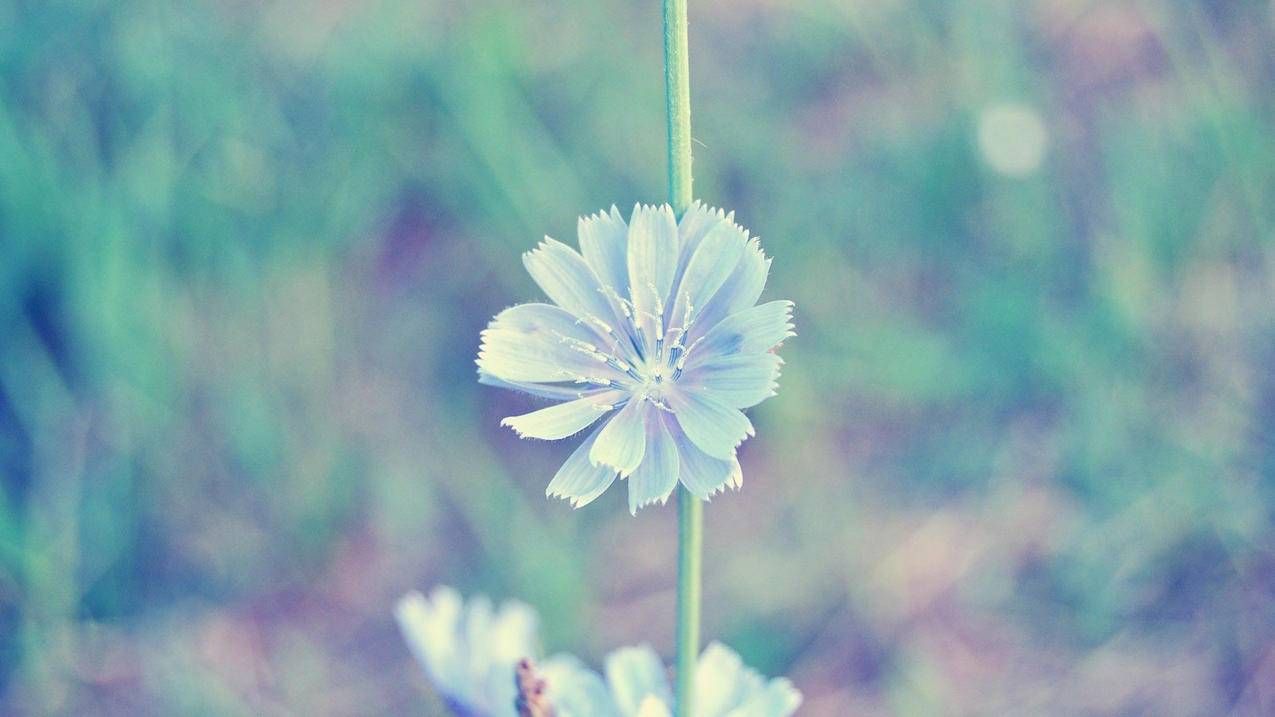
[{"left": 478, "top": 304, "right": 625, "bottom": 389}]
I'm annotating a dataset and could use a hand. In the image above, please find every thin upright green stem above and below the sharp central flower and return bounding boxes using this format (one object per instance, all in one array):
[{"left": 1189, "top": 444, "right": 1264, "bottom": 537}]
[{"left": 664, "top": 0, "right": 704, "bottom": 717}]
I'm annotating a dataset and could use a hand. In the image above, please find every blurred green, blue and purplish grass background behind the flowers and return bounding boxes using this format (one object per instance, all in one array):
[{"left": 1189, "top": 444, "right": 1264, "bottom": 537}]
[{"left": 0, "top": 0, "right": 1275, "bottom": 716}]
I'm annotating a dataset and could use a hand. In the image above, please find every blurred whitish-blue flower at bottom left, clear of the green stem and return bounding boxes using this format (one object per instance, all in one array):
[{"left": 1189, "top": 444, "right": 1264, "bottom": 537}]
[{"left": 394, "top": 586, "right": 538, "bottom": 717}]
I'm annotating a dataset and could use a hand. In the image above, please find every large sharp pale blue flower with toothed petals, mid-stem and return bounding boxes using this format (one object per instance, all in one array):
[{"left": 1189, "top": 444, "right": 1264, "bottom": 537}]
[{"left": 477, "top": 203, "right": 793, "bottom": 513}]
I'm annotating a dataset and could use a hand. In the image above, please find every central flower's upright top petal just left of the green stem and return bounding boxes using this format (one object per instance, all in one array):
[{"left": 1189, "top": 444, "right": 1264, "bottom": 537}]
[{"left": 629, "top": 204, "right": 677, "bottom": 314}]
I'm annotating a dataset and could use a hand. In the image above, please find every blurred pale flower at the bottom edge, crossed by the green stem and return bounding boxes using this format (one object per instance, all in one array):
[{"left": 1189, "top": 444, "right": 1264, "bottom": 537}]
[{"left": 539, "top": 643, "right": 801, "bottom": 717}]
